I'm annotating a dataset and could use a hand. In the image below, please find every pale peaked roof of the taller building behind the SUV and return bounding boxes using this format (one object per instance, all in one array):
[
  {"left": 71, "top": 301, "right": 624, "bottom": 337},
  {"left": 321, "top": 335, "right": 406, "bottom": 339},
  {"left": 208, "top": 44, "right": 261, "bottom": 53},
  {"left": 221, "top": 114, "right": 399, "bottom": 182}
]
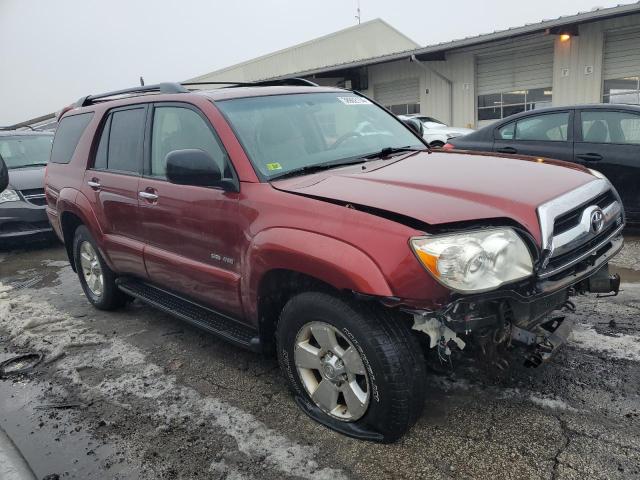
[{"left": 189, "top": 18, "right": 419, "bottom": 82}]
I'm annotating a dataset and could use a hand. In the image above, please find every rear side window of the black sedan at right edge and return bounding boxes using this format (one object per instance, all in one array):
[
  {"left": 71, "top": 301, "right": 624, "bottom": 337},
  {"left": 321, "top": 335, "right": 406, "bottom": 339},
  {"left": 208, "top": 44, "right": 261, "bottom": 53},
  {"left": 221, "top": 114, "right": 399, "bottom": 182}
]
[{"left": 581, "top": 111, "right": 640, "bottom": 145}]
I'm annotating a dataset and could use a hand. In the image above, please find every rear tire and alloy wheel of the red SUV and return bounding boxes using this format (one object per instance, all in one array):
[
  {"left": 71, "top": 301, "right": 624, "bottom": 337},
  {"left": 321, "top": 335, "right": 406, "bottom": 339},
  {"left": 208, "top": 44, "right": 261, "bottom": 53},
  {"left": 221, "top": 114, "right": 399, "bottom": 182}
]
[{"left": 73, "top": 225, "right": 128, "bottom": 310}]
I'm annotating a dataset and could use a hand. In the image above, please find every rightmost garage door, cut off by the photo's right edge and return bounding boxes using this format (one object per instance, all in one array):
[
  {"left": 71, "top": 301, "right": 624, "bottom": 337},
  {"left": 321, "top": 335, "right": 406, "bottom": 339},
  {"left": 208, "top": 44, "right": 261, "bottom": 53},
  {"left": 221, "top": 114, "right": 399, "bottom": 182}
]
[{"left": 602, "top": 28, "right": 640, "bottom": 104}]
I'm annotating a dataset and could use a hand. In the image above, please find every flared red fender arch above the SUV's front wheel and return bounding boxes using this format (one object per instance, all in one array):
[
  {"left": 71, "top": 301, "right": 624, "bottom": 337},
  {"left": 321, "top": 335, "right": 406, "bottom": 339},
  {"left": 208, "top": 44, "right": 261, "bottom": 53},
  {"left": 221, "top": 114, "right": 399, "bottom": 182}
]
[{"left": 242, "top": 228, "right": 393, "bottom": 318}]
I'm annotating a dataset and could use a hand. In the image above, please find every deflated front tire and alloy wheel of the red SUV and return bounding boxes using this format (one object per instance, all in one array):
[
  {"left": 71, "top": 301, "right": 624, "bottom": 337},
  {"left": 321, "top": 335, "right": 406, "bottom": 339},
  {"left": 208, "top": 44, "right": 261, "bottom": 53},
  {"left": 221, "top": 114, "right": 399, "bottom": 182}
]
[{"left": 276, "top": 292, "right": 426, "bottom": 443}]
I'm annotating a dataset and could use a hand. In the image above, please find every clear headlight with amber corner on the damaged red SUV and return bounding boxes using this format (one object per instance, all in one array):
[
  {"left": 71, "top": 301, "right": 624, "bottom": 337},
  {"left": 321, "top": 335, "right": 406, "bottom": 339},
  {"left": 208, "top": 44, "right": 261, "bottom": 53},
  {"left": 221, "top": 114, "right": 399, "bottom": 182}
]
[{"left": 411, "top": 228, "right": 533, "bottom": 293}]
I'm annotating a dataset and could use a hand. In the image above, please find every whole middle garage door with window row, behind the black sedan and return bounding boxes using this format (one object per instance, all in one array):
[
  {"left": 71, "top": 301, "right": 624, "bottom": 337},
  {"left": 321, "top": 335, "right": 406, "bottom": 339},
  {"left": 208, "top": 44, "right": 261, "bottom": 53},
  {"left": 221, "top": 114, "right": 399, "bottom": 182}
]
[{"left": 476, "top": 36, "right": 553, "bottom": 122}]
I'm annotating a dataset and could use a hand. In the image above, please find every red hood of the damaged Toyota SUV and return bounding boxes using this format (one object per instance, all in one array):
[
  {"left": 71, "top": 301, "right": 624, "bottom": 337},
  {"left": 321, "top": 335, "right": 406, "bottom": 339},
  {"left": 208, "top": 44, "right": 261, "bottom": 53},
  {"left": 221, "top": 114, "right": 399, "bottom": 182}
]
[{"left": 272, "top": 152, "right": 594, "bottom": 243}]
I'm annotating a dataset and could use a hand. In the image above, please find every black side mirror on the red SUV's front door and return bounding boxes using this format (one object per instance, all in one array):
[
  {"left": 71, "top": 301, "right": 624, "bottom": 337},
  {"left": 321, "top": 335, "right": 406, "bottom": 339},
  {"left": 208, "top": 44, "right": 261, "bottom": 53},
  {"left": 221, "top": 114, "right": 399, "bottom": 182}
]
[{"left": 166, "top": 148, "right": 235, "bottom": 190}]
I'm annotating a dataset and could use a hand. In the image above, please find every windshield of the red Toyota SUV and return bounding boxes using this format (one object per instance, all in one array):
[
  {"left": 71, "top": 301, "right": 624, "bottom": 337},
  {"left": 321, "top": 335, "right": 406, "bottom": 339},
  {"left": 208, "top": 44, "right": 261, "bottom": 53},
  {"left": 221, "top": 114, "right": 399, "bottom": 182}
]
[{"left": 216, "top": 92, "right": 424, "bottom": 179}]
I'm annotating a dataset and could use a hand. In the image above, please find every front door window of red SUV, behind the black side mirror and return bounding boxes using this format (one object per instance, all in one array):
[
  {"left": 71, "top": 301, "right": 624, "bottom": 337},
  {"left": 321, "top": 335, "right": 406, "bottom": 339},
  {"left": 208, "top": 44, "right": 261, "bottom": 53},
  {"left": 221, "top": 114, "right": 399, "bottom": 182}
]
[{"left": 151, "top": 107, "right": 231, "bottom": 178}]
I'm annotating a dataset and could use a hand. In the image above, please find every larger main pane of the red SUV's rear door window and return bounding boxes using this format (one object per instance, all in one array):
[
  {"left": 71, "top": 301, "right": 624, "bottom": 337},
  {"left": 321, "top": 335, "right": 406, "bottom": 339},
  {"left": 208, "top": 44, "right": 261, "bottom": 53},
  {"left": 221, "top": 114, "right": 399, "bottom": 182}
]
[{"left": 105, "top": 108, "right": 145, "bottom": 172}]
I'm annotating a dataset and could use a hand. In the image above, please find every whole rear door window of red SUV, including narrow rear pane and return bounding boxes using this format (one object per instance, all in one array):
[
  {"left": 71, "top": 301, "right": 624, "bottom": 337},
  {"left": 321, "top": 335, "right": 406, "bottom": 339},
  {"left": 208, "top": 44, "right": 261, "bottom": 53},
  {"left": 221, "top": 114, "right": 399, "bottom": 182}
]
[{"left": 93, "top": 107, "right": 146, "bottom": 173}]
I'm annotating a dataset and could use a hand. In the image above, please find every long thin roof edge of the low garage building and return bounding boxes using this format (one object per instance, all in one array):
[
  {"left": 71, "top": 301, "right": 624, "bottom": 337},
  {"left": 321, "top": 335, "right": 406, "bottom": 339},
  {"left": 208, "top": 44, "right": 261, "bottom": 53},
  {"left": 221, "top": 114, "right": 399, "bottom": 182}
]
[{"left": 274, "top": 1, "right": 640, "bottom": 79}]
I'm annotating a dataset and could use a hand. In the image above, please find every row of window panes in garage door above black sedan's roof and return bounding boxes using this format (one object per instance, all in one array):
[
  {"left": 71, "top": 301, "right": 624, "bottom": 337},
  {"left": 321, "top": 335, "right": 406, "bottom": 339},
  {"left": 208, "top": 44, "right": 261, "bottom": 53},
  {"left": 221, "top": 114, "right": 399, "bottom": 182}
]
[{"left": 478, "top": 87, "right": 552, "bottom": 120}]
